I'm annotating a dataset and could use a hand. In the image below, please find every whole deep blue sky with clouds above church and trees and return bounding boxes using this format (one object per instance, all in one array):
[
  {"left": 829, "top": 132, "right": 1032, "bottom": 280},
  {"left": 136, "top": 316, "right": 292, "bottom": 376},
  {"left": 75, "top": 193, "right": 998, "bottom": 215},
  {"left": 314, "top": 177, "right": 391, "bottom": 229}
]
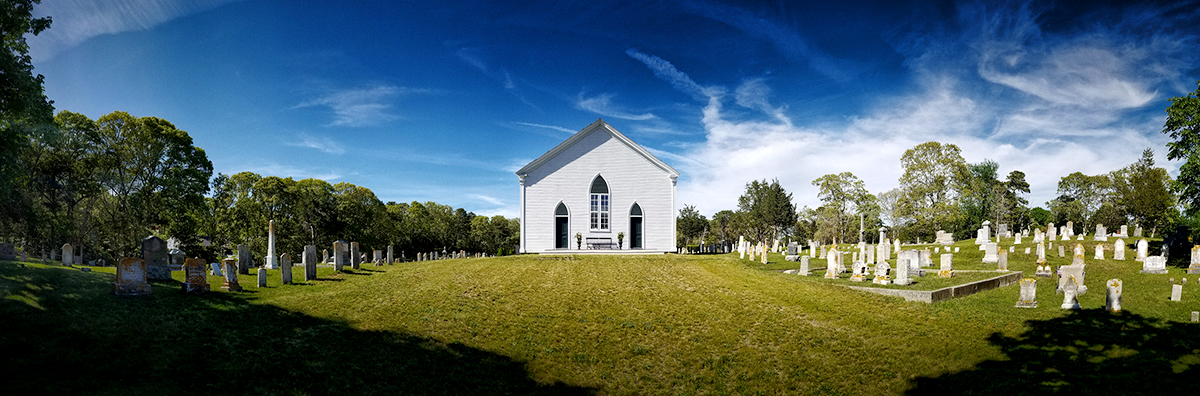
[{"left": 29, "top": 0, "right": 1200, "bottom": 217}]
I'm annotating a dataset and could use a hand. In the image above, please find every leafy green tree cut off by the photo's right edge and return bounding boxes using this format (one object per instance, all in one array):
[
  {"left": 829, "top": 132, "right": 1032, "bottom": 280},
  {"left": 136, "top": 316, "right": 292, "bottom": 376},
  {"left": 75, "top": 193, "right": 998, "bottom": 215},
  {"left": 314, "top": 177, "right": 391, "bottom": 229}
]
[{"left": 1163, "top": 82, "right": 1200, "bottom": 216}]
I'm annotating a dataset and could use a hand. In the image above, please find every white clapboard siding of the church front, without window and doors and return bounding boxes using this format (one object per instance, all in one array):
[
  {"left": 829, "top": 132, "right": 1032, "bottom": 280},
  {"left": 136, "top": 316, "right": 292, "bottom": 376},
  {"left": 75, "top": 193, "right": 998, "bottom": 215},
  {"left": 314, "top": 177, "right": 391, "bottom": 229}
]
[{"left": 517, "top": 120, "right": 679, "bottom": 253}]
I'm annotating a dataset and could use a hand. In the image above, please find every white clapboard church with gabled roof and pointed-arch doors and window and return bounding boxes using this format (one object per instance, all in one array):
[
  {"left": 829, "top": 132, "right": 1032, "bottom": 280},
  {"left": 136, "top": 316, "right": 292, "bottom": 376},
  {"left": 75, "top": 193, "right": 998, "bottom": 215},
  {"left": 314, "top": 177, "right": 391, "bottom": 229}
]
[{"left": 517, "top": 120, "right": 679, "bottom": 254}]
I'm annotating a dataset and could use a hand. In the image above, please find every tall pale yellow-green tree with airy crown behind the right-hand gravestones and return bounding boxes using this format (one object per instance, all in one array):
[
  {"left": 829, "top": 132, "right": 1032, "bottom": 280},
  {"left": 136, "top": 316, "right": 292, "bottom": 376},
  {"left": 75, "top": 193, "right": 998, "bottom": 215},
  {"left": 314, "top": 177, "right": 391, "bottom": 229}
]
[{"left": 898, "top": 142, "right": 970, "bottom": 238}]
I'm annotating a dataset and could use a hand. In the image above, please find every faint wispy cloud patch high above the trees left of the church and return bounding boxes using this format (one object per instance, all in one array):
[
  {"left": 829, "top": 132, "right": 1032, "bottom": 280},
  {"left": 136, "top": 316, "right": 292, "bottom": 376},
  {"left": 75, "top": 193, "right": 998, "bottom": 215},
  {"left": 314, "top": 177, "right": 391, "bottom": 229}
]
[{"left": 295, "top": 85, "right": 443, "bottom": 127}]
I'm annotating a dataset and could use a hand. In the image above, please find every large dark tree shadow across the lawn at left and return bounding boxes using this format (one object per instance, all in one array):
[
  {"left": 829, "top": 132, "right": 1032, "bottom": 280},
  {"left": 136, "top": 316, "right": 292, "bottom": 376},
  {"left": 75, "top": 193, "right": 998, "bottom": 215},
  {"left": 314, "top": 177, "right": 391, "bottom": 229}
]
[{"left": 0, "top": 263, "right": 594, "bottom": 395}]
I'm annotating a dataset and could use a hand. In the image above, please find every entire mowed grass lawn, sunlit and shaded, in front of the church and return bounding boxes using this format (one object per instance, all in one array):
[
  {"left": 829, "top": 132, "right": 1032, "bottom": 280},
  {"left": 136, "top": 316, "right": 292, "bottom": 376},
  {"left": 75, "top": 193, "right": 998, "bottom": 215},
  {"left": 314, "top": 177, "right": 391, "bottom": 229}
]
[{"left": 0, "top": 236, "right": 1200, "bottom": 395}]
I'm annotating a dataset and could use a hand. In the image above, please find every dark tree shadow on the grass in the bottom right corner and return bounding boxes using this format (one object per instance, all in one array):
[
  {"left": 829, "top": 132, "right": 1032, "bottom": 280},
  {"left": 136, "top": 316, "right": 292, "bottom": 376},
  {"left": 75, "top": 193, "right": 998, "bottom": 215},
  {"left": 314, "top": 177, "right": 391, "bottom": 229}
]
[{"left": 907, "top": 308, "right": 1200, "bottom": 396}]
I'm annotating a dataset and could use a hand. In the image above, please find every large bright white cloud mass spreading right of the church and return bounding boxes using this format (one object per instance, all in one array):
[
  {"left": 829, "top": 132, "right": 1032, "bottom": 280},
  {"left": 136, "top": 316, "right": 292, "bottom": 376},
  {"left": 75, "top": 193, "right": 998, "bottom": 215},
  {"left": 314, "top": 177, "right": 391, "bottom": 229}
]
[{"left": 633, "top": 2, "right": 1198, "bottom": 212}]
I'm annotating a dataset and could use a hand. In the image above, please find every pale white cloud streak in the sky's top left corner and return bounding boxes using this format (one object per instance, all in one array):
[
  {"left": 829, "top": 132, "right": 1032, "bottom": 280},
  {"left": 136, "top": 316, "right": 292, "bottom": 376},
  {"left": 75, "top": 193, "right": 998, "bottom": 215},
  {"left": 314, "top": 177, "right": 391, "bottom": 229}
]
[{"left": 28, "top": 0, "right": 241, "bottom": 60}]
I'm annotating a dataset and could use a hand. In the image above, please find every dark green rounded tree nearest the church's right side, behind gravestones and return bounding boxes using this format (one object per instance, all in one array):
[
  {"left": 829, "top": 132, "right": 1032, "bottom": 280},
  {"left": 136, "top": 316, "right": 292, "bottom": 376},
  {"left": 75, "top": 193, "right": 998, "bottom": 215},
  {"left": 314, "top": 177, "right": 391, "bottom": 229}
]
[{"left": 738, "top": 179, "right": 796, "bottom": 242}]
